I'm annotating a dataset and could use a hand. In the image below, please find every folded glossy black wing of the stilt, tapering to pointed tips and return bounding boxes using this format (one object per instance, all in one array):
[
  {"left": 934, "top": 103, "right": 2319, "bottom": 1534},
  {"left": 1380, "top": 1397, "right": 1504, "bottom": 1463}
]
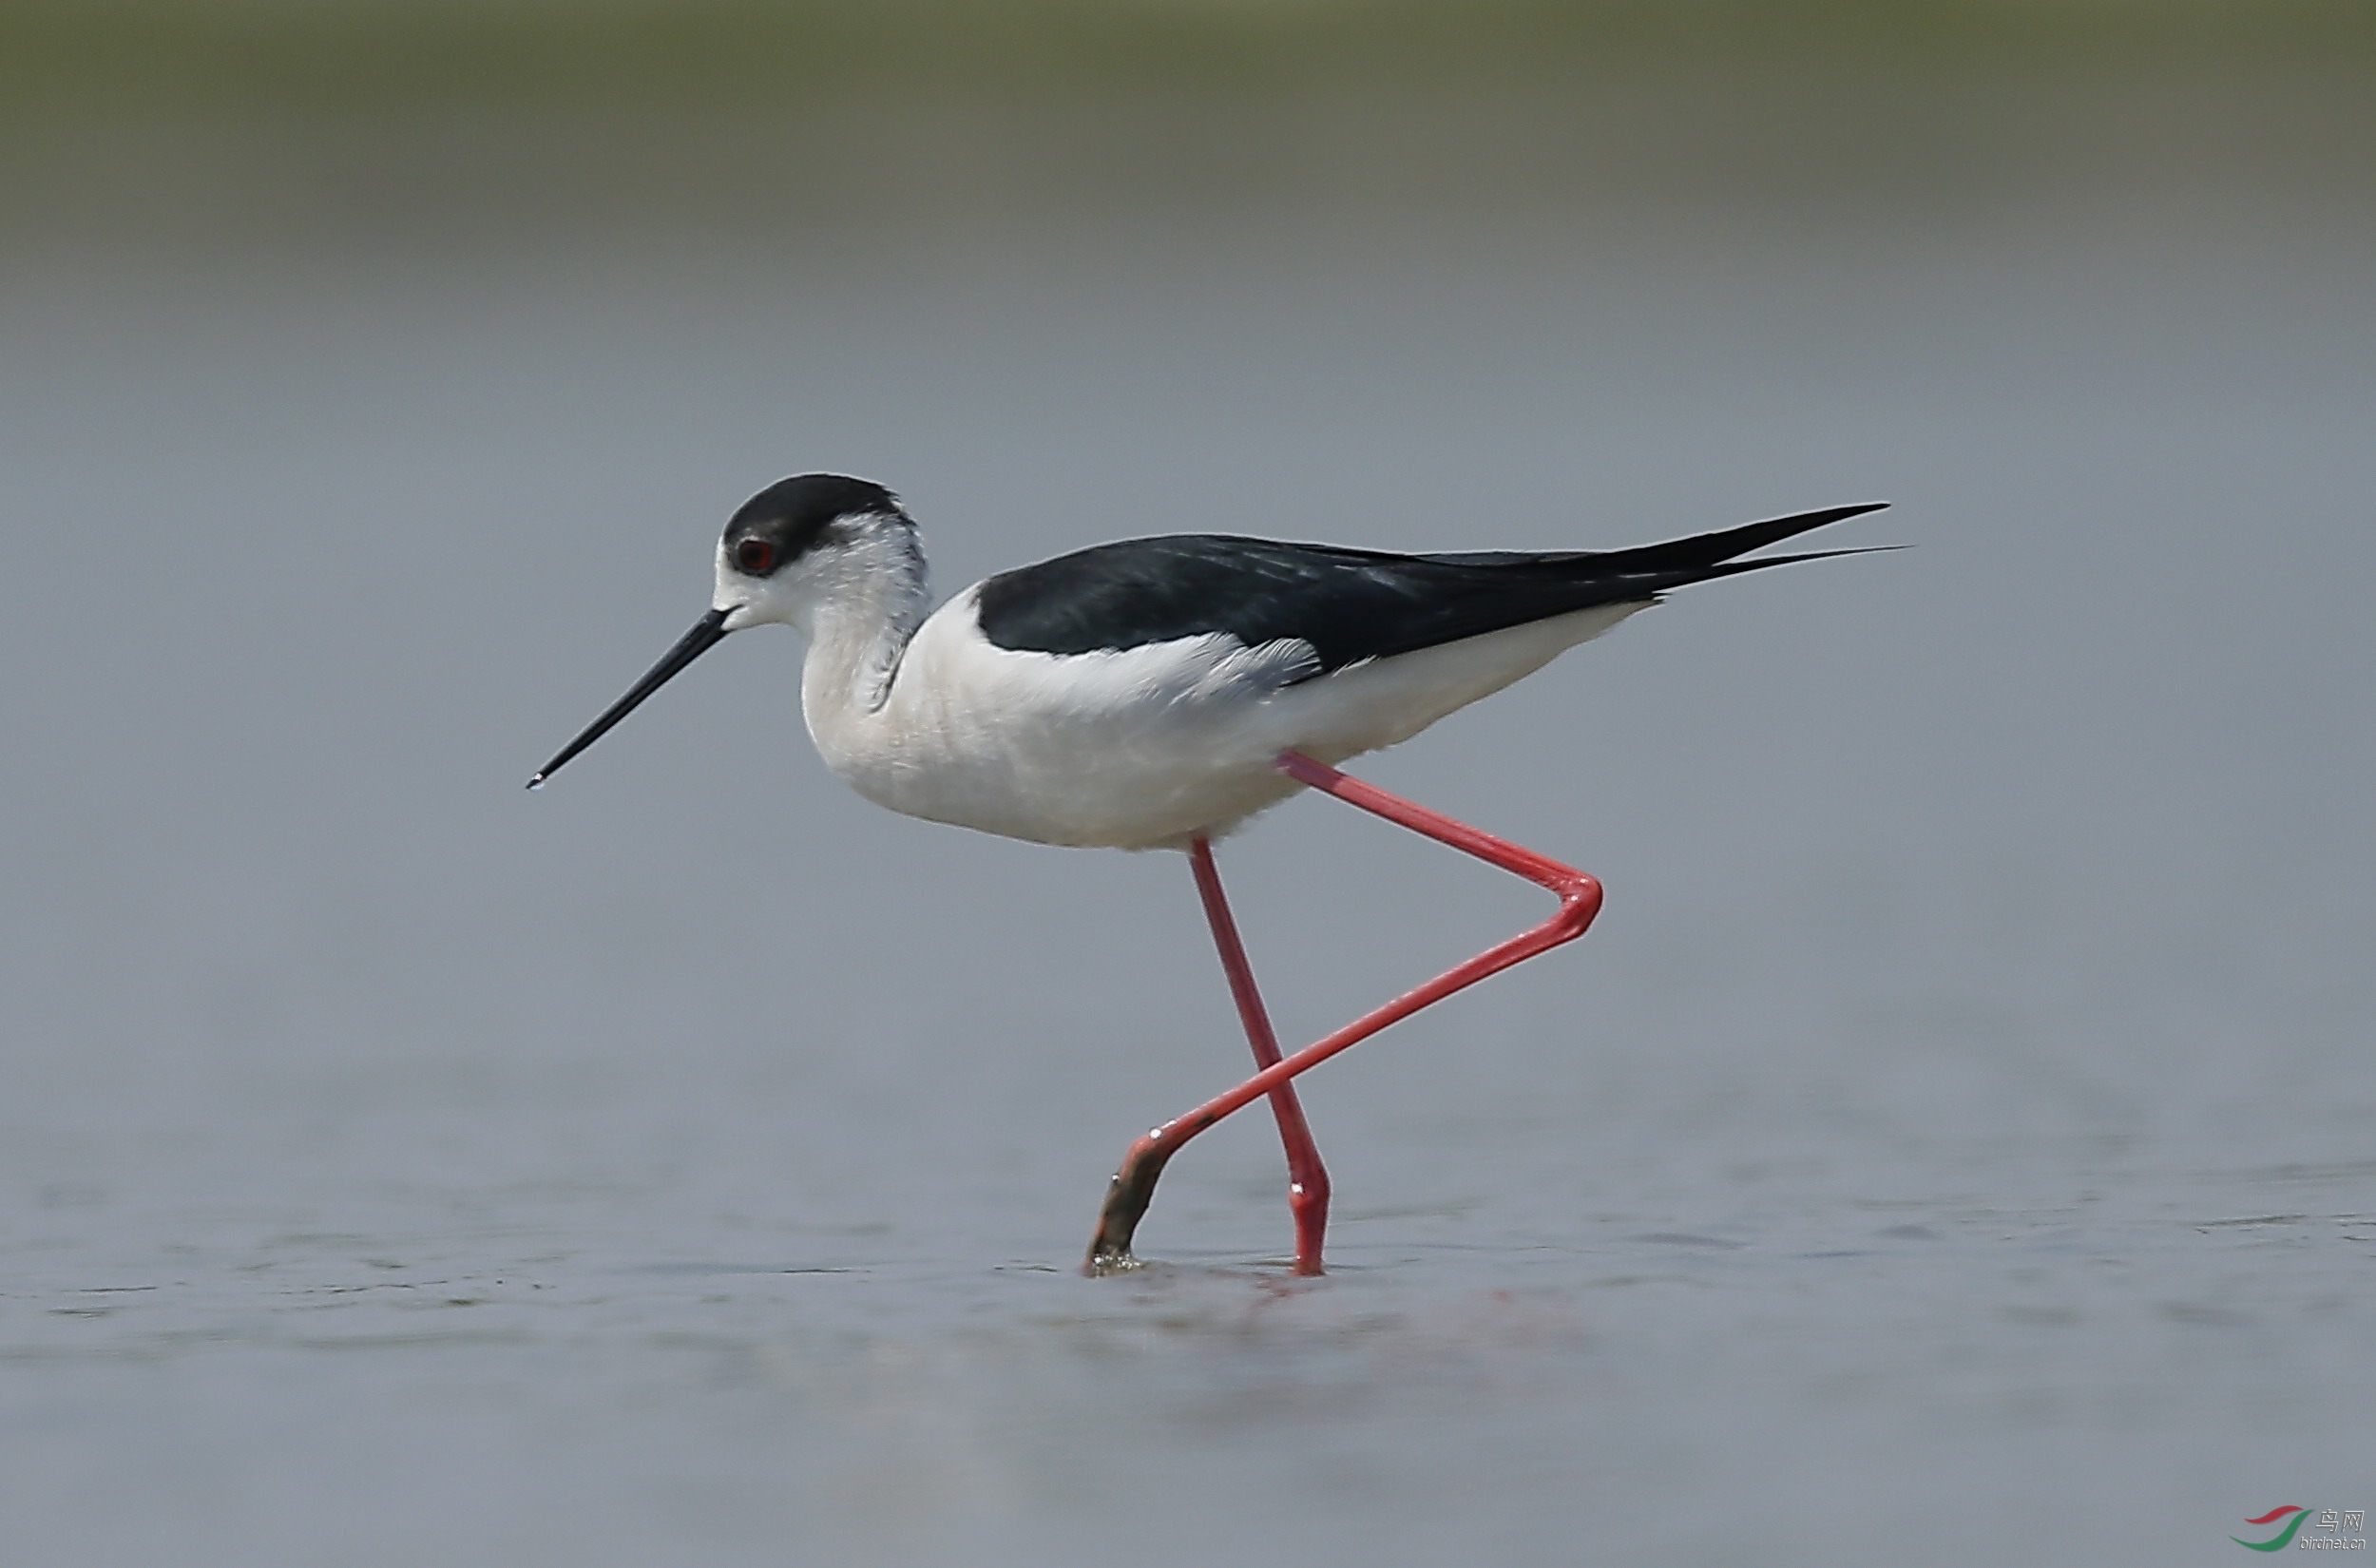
[{"left": 979, "top": 502, "right": 1885, "bottom": 675}]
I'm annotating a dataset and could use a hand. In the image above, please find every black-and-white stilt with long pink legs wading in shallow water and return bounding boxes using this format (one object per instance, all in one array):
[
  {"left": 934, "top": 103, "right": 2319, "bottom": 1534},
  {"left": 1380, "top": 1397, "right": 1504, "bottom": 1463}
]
[{"left": 527, "top": 473, "right": 1880, "bottom": 1273}]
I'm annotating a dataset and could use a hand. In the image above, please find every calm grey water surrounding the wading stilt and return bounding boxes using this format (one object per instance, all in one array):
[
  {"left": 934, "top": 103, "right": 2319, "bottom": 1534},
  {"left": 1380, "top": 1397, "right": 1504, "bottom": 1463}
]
[{"left": 0, "top": 214, "right": 2376, "bottom": 1568}]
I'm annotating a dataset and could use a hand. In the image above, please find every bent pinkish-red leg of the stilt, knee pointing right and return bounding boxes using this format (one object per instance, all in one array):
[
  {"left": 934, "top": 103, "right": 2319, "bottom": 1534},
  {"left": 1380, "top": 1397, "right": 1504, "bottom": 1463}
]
[{"left": 1086, "top": 751, "right": 1601, "bottom": 1273}]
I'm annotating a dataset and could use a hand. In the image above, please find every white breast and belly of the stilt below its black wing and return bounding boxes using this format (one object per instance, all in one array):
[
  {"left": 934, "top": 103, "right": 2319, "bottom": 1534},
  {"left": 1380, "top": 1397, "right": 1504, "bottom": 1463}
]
[{"left": 803, "top": 594, "right": 1642, "bottom": 849}]
